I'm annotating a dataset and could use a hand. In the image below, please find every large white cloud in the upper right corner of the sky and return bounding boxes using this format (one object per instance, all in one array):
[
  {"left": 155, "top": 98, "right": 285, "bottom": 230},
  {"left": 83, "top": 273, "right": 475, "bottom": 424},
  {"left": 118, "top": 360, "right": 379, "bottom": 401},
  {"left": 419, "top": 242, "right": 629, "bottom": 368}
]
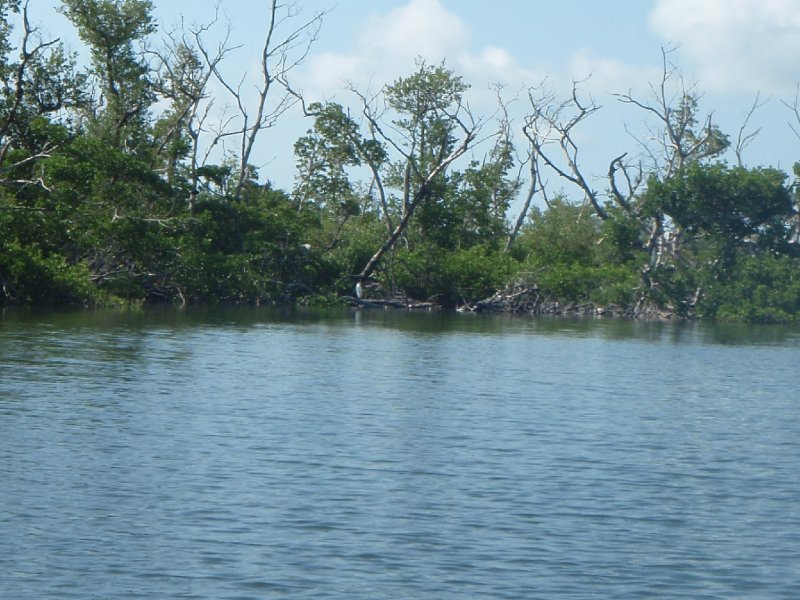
[{"left": 650, "top": 0, "right": 800, "bottom": 94}]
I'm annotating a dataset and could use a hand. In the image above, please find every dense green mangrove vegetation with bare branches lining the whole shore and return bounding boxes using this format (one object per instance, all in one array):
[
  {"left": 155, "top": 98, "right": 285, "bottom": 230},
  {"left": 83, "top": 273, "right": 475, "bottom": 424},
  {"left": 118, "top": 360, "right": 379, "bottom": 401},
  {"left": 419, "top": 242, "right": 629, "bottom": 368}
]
[{"left": 0, "top": 0, "right": 800, "bottom": 321}]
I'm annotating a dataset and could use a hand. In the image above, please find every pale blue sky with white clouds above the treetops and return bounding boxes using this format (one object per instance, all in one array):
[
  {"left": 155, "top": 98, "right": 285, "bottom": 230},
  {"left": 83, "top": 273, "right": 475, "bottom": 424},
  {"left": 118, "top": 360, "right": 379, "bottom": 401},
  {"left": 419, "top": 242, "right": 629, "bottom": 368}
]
[{"left": 30, "top": 0, "right": 800, "bottom": 202}]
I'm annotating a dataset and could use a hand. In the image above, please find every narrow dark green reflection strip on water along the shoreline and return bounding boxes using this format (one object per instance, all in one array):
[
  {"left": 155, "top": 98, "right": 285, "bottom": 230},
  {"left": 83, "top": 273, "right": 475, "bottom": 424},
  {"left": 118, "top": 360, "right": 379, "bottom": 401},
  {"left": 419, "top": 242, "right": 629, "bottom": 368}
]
[{"left": 7, "top": 307, "right": 800, "bottom": 348}]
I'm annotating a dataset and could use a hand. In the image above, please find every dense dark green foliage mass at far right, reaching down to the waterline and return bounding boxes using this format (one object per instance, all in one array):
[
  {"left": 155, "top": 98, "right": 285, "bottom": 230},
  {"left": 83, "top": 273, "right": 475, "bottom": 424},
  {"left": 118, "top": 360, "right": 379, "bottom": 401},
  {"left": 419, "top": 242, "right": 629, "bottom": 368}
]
[{"left": 643, "top": 164, "right": 797, "bottom": 320}]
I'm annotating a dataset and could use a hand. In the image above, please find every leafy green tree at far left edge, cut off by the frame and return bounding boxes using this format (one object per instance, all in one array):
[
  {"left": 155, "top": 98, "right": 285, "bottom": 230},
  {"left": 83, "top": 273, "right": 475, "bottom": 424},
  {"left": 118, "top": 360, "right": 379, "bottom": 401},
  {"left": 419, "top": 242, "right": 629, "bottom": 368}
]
[{"left": 0, "top": 1, "right": 91, "bottom": 304}]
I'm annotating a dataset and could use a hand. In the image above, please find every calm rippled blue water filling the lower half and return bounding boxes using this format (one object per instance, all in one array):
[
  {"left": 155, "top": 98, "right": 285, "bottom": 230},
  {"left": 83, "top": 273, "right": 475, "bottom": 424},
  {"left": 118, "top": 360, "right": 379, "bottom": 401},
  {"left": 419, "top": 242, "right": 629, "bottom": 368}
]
[{"left": 0, "top": 309, "right": 800, "bottom": 600}]
